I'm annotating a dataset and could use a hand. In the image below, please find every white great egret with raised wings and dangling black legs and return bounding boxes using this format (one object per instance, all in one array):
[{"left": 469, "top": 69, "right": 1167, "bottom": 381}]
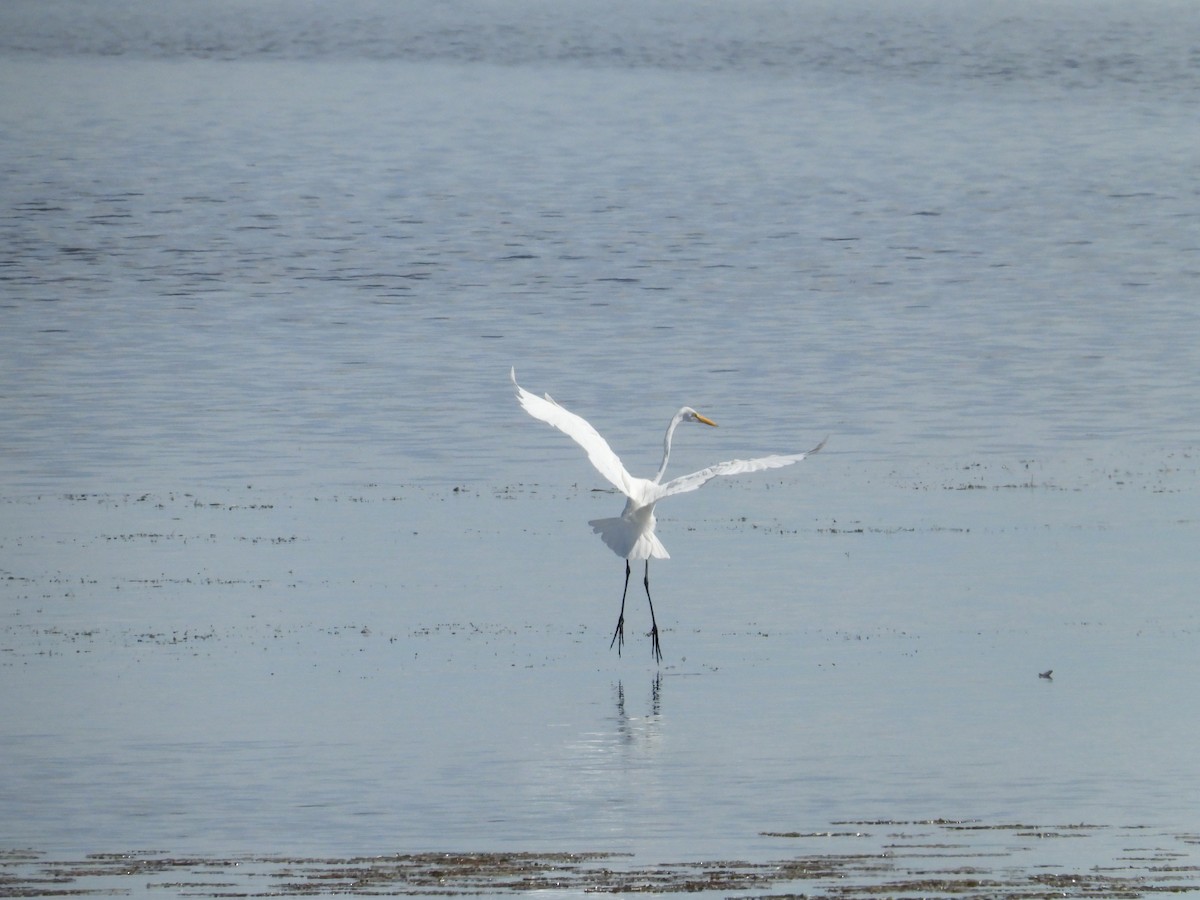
[{"left": 509, "top": 366, "right": 824, "bottom": 662}]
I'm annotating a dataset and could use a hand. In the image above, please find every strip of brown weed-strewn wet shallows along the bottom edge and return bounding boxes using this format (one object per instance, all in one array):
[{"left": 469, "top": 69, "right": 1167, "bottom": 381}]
[{"left": 0, "top": 820, "right": 1200, "bottom": 900}]
